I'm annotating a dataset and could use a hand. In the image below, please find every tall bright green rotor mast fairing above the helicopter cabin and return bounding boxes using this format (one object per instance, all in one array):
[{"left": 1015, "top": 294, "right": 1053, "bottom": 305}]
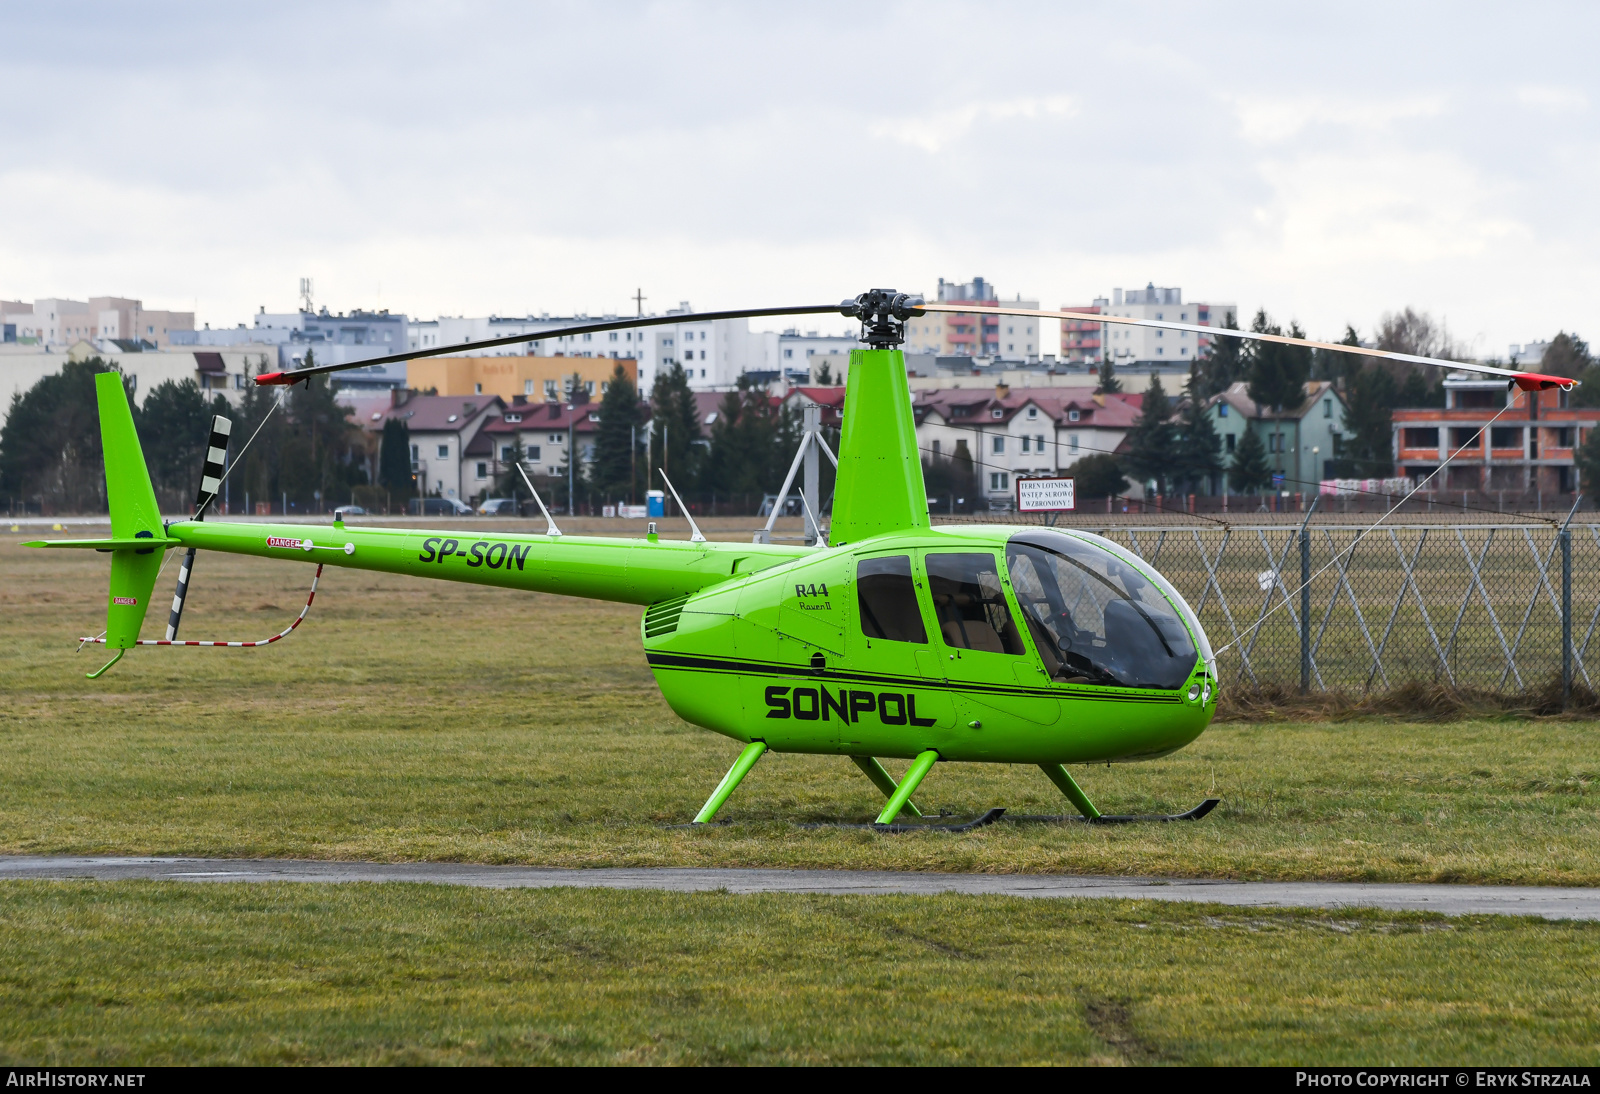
[{"left": 827, "top": 349, "right": 928, "bottom": 547}]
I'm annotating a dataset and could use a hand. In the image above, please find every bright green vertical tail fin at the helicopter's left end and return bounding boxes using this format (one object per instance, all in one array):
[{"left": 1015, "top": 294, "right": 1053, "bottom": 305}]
[{"left": 94, "top": 373, "right": 166, "bottom": 649}]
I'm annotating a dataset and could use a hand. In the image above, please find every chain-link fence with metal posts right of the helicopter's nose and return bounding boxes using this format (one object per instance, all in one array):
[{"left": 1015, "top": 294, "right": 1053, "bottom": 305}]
[{"left": 936, "top": 515, "right": 1600, "bottom": 693}]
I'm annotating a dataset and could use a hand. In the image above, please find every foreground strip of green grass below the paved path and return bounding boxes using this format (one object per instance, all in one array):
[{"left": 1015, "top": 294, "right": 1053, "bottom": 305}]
[{"left": 0, "top": 883, "right": 1600, "bottom": 1067}]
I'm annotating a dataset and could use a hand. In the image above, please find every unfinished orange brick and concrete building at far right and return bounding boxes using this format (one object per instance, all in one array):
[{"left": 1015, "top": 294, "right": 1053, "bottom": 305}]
[{"left": 1392, "top": 373, "right": 1600, "bottom": 494}]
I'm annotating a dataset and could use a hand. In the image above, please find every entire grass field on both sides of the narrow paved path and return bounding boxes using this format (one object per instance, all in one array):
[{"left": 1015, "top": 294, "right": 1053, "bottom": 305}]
[{"left": 0, "top": 524, "right": 1600, "bottom": 1065}]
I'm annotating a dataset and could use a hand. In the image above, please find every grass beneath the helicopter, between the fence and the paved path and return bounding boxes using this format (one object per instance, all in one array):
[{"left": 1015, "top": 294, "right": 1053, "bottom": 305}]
[{"left": 0, "top": 544, "right": 1600, "bottom": 884}]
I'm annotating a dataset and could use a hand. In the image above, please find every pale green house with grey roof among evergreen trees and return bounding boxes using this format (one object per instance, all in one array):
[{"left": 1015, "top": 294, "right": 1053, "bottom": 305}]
[{"left": 1206, "top": 381, "right": 1346, "bottom": 494}]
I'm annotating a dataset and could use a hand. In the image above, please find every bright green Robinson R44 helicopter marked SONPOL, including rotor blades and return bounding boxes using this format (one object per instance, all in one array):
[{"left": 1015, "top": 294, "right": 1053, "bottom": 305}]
[{"left": 27, "top": 289, "right": 1573, "bottom": 825}]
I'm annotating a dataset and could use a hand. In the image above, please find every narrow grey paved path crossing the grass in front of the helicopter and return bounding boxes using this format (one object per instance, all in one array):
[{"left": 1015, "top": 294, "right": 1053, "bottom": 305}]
[{"left": 0, "top": 856, "right": 1600, "bottom": 920}]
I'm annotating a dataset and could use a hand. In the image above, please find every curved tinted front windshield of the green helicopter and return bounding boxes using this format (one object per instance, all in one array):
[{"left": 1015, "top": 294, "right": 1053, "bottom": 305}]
[{"left": 1006, "top": 529, "right": 1198, "bottom": 689}]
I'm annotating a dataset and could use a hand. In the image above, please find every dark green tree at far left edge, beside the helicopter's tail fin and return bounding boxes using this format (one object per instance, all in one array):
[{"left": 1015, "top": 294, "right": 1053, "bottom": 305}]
[{"left": 0, "top": 357, "right": 133, "bottom": 512}]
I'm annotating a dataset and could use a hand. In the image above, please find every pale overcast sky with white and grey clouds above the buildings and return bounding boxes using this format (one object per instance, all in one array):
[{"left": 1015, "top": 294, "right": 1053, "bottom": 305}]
[{"left": 0, "top": 0, "right": 1600, "bottom": 355}]
